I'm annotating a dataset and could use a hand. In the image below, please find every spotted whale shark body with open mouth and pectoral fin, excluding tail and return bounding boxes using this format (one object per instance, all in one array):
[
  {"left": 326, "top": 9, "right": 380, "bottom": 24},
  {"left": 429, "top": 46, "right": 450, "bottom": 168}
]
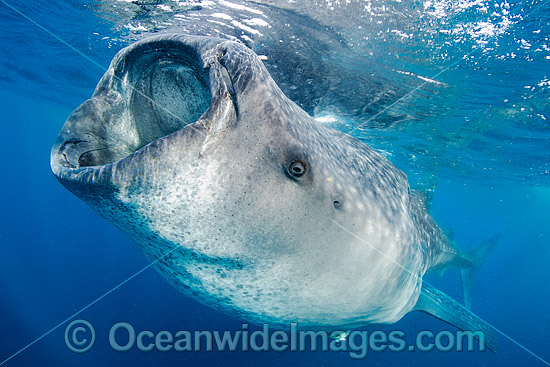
[{"left": 51, "top": 35, "right": 496, "bottom": 349}]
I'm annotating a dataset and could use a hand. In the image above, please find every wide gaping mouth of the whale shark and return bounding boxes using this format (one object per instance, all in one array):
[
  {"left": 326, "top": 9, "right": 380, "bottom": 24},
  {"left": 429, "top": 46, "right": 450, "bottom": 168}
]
[{"left": 52, "top": 43, "right": 211, "bottom": 168}]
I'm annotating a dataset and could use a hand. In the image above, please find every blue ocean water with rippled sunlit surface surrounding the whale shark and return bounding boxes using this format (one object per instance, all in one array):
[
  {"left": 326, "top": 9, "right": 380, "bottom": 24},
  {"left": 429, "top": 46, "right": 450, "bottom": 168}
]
[{"left": 0, "top": 0, "right": 550, "bottom": 366}]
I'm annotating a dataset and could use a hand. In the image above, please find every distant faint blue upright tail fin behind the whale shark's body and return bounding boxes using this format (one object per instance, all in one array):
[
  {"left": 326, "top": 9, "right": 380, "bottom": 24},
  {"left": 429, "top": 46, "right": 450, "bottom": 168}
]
[{"left": 460, "top": 230, "right": 507, "bottom": 310}]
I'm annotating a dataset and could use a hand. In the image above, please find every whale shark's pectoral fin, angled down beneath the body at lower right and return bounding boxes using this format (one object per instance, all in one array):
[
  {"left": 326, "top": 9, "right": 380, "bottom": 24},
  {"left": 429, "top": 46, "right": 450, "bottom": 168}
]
[{"left": 414, "top": 284, "right": 498, "bottom": 352}]
